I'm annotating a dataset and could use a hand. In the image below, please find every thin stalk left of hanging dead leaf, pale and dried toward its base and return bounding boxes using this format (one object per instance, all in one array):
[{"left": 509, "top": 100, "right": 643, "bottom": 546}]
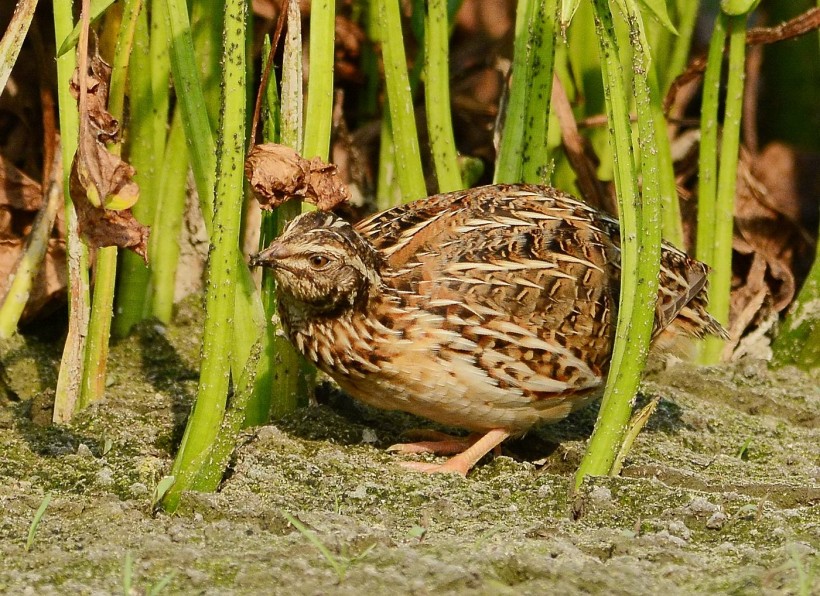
[{"left": 53, "top": 0, "right": 90, "bottom": 423}]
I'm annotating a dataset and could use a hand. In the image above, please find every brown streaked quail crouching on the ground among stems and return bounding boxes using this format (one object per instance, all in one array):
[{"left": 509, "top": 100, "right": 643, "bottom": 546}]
[{"left": 252, "top": 185, "right": 726, "bottom": 475}]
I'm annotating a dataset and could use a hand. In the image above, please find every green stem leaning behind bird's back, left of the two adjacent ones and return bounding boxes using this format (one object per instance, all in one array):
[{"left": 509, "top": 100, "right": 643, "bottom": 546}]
[{"left": 379, "top": 0, "right": 427, "bottom": 201}]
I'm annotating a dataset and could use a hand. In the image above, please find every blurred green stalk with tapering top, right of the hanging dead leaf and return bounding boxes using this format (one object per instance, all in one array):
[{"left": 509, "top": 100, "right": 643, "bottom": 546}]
[{"left": 149, "top": 110, "right": 189, "bottom": 323}]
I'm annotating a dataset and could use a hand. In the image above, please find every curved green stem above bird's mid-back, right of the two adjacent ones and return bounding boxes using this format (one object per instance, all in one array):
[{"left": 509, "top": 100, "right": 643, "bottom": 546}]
[{"left": 424, "top": 0, "right": 463, "bottom": 192}]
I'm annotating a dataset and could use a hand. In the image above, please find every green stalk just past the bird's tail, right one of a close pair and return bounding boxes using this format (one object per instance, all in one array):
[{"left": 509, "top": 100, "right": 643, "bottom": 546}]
[{"left": 698, "top": 15, "right": 746, "bottom": 364}]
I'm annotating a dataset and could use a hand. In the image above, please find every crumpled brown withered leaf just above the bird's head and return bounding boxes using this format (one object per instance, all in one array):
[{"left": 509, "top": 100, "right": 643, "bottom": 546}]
[{"left": 245, "top": 143, "right": 350, "bottom": 211}]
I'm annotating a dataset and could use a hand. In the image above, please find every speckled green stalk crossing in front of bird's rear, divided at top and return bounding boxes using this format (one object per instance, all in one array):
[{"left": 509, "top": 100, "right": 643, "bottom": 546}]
[{"left": 575, "top": 0, "right": 660, "bottom": 487}]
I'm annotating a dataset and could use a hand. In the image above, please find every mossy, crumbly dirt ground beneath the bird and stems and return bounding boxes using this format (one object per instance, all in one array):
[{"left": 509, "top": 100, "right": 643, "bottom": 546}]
[{"left": 0, "top": 303, "right": 820, "bottom": 595}]
